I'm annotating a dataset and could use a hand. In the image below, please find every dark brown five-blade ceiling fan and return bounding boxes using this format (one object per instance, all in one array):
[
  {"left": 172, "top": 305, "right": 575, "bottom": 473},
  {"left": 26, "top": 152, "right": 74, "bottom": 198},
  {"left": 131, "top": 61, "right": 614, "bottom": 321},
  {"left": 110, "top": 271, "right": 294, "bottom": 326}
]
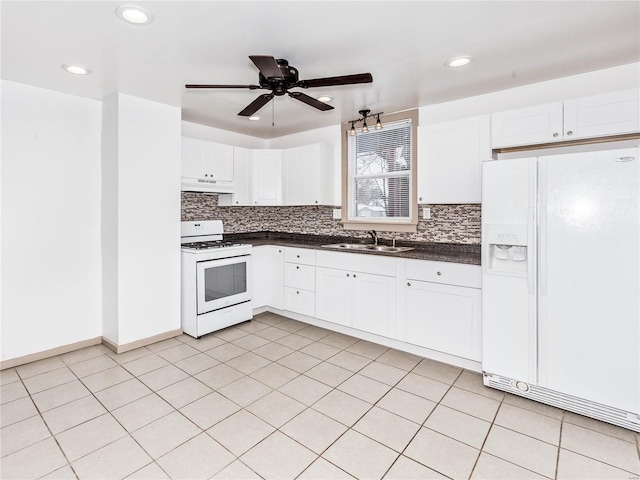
[{"left": 185, "top": 55, "right": 373, "bottom": 117}]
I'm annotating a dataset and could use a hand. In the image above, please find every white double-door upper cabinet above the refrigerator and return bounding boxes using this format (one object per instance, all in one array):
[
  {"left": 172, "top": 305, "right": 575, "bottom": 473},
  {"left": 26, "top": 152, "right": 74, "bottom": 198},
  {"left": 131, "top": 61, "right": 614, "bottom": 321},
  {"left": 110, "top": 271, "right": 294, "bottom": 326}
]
[{"left": 491, "top": 89, "right": 640, "bottom": 148}]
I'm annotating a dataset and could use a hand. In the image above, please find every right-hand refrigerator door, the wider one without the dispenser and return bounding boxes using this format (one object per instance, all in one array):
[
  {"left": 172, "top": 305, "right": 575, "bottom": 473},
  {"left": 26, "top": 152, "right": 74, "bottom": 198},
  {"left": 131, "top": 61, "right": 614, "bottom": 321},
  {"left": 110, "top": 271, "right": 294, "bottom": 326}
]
[{"left": 539, "top": 148, "right": 640, "bottom": 412}]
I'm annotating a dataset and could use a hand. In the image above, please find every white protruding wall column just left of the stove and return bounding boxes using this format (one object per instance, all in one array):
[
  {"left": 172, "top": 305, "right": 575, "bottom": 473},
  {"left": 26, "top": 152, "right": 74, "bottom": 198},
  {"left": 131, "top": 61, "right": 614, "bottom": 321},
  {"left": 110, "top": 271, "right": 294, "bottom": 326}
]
[{"left": 102, "top": 94, "right": 181, "bottom": 345}]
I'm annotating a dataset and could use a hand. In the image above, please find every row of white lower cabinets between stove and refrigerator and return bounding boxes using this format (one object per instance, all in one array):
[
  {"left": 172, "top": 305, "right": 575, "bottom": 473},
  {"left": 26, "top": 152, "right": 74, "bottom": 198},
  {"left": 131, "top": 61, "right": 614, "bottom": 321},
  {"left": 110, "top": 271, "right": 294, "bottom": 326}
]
[{"left": 253, "top": 246, "right": 481, "bottom": 362}]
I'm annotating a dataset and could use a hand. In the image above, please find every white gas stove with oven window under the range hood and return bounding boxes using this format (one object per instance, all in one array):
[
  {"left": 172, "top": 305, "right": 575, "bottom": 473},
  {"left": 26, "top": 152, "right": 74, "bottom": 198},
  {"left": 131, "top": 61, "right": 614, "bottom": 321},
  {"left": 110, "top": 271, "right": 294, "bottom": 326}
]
[{"left": 181, "top": 220, "right": 253, "bottom": 338}]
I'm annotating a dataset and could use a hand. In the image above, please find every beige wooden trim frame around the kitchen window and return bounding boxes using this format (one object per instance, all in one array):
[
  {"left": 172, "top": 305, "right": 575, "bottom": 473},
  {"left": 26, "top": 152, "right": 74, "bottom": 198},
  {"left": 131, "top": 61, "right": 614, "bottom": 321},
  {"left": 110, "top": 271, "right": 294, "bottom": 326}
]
[{"left": 341, "top": 109, "right": 418, "bottom": 232}]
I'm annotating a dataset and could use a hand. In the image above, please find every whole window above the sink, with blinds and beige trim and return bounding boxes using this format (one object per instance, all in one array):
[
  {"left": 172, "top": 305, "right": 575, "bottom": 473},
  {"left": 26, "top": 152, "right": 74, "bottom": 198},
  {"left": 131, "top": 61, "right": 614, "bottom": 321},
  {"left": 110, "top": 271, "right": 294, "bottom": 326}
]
[{"left": 342, "top": 110, "right": 418, "bottom": 232}]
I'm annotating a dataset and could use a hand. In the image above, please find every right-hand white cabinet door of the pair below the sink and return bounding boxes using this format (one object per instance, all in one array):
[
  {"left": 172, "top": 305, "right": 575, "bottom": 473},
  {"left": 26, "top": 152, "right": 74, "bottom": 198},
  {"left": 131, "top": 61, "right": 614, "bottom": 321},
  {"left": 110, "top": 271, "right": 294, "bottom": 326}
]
[{"left": 351, "top": 272, "right": 397, "bottom": 337}]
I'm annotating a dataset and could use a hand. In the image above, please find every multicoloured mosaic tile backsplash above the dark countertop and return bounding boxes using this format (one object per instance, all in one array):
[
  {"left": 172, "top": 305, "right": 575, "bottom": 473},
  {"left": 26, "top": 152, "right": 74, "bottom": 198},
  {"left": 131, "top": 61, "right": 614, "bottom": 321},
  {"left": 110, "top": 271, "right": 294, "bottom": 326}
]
[{"left": 181, "top": 192, "right": 480, "bottom": 245}]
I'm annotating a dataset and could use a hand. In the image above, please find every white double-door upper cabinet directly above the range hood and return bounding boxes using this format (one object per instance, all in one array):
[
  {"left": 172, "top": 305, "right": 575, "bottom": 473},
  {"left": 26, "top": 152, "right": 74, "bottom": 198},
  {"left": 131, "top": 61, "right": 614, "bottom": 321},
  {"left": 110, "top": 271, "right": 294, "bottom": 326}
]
[{"left": 182, "top": 137, "right": 233, "bottom": 183}]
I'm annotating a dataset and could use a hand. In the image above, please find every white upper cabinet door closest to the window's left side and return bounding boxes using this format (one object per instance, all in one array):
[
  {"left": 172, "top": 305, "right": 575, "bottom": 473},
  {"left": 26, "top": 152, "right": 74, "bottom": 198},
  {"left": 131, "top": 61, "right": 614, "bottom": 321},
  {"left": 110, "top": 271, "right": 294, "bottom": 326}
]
[{"left": 282, "top": 143, "right": 325, "bottom": 205}]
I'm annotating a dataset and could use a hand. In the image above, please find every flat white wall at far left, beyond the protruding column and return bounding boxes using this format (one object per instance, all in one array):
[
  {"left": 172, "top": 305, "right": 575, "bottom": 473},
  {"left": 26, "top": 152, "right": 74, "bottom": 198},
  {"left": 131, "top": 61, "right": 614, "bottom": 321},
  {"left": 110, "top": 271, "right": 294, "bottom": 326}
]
[{"left": 0, "top": 80, "right": 102, "bottom": 360}]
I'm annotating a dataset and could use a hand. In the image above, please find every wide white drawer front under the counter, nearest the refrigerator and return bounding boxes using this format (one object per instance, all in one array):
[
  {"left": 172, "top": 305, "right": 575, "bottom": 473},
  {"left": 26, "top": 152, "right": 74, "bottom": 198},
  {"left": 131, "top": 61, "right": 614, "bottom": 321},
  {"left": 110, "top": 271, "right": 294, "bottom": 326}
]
[{"left": 407, "top": 260, "right": 482, "bottom": 288}]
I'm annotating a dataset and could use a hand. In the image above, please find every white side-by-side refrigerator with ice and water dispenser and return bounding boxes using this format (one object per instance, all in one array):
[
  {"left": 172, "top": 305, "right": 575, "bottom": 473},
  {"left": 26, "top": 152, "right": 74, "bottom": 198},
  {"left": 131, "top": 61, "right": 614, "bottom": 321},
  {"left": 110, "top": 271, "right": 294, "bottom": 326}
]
[{"left": 482, "top": 143, "right": 640, "bottom": 431}]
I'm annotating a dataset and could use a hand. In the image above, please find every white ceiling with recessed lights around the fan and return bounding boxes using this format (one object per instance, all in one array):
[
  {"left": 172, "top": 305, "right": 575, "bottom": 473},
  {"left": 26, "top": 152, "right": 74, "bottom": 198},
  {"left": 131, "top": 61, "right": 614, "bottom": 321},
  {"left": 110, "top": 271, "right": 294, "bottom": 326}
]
[{"left": 0, "top": 0, "right": 640, "bottom": 138}]
